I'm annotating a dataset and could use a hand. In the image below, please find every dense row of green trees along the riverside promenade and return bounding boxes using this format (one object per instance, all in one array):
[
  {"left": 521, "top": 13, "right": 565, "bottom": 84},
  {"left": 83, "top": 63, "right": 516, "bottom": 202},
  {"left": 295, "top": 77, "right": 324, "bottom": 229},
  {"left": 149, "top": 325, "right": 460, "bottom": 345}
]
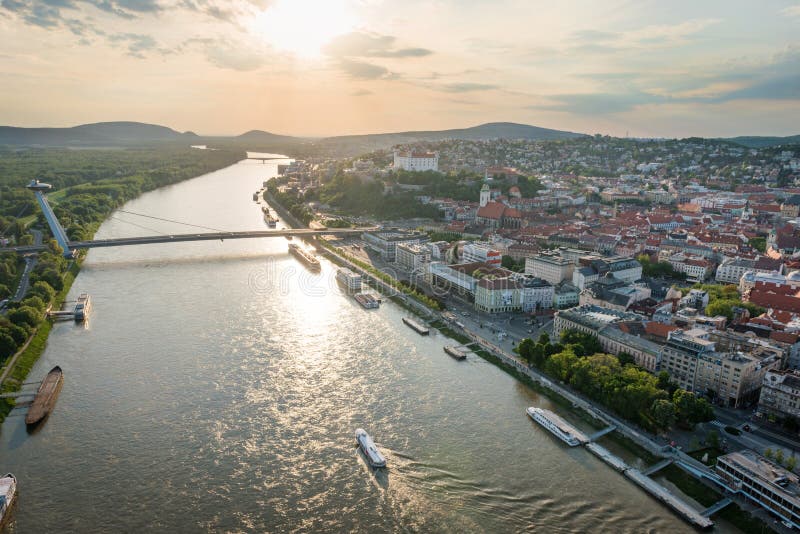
[{"left": 517, "top": 330, "right": 714, "bottom": 430}]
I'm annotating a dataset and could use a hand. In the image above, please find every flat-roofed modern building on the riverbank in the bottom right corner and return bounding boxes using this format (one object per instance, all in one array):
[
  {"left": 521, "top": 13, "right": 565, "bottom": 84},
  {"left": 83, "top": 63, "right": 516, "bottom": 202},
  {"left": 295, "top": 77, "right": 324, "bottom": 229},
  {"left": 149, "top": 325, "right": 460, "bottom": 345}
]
[{"left": 716, "top": 449, "right": 800, "bottom": 528}]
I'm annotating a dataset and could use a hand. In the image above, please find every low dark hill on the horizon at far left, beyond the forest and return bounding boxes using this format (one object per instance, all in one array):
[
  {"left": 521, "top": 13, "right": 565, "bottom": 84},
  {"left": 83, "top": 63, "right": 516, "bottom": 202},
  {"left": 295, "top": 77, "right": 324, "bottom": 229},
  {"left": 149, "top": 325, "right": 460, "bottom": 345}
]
[{"left": 0, "top": 122, "right": 197, "bottom": 146}]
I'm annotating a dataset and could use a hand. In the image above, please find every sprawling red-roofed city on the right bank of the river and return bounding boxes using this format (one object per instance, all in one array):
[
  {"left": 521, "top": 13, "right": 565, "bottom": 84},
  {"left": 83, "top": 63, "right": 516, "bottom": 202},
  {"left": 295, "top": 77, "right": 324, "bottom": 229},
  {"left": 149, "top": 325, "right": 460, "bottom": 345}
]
[{"left": 262, "top": 136, "right": 800, "bottom": 532}]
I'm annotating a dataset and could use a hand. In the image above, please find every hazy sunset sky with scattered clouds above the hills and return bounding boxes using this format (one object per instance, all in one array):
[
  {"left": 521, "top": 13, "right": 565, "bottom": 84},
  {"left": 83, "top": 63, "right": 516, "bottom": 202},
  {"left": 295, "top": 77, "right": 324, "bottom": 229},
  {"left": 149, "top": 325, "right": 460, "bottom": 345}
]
[{"left": 0, "top": 0, "right": 800, "bottom": 137}]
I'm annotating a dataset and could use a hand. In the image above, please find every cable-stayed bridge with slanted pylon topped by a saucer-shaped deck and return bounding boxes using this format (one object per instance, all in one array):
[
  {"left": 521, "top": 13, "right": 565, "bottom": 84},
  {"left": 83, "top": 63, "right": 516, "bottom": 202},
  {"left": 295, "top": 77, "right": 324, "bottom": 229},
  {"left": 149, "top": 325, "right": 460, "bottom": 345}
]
[{"left": 20, "top": 181, "right": 375, "bottom": 258}]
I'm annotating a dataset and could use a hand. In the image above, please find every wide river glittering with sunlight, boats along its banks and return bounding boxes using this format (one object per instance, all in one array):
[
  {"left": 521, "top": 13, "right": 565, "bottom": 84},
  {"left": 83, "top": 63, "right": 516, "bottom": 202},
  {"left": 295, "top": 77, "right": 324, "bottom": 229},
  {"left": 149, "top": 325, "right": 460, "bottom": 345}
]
[{"left": 0, "top": 157, "right": 736, "bottom": 532}]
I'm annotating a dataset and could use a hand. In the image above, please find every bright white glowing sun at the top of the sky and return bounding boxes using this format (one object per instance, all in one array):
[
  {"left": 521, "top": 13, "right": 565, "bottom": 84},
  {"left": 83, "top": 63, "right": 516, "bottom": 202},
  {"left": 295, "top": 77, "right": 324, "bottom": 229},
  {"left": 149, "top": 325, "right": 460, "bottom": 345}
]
[{"left": 254, "top": 0, "right": 355, "bottom": 58}]
